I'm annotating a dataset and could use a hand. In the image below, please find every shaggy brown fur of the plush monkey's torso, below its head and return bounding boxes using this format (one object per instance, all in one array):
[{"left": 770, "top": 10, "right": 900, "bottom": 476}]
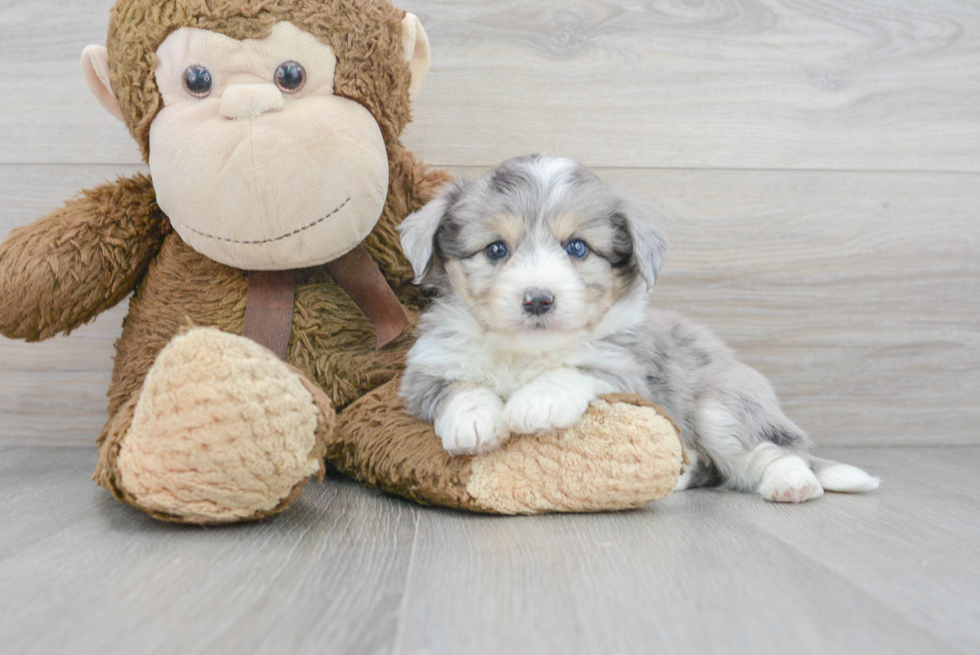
[{"left": 88, "top": 152, "right": 445, "bottom": 520}]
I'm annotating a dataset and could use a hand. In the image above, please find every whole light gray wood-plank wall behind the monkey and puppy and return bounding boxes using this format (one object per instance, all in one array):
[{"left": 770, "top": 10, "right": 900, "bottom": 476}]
[{"left": 0, "top": 0, "right": 980, "bottom": 445}]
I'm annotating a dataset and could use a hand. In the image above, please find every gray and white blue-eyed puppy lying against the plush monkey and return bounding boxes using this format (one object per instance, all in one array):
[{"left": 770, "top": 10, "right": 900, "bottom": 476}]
[{"left": 399, "top": 155, "right": 878, "bottom": 502}]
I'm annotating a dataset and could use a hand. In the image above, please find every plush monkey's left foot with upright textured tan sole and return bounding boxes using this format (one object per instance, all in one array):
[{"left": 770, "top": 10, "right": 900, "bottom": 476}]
[{"left": 93, "top": 328, "right": 335, "bottom": 524}]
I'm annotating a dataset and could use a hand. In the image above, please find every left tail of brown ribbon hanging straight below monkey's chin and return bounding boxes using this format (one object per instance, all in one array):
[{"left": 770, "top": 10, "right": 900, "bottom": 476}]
[{"left": 242, "top": 271, "right": 296, "bottom": 361}]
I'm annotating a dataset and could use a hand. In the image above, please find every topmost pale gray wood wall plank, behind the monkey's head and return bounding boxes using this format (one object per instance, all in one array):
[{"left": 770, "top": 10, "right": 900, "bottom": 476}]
[{"left": 0, "top": 0, "right": 980, "bottom": 171}]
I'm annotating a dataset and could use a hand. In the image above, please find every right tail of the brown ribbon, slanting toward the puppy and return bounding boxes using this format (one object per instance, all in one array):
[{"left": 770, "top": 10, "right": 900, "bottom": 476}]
[{"left": 326, "top": 245, "right": 408, "bottom": 350}]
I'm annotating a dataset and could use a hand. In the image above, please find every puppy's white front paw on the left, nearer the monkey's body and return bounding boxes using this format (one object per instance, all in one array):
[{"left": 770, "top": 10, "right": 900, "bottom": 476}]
[{"left": 435, "top": 388, "right": 508, "bottom": 455}]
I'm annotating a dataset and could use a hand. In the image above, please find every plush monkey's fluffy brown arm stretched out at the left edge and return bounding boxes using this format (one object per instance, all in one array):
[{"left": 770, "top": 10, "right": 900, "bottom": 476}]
[{"left": 0, "top": 174, "right": 170, "bottom": 341}]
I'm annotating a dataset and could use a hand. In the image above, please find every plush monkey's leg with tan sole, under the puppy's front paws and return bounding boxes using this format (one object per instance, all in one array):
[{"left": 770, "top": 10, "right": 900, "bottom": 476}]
[{"left": 327, "top": 378, "right": 684, "bottom": 514}]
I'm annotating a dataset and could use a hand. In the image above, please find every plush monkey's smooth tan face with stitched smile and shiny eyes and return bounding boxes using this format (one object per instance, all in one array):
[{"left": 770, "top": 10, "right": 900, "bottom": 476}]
[{"left": 150, "top": 23, "right": 388, "bottom": 270}]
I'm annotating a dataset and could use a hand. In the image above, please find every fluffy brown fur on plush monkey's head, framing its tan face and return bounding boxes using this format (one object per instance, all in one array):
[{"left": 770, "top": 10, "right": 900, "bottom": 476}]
[{"left": 107, "top": 0, "right": 411, "bottom": 159}]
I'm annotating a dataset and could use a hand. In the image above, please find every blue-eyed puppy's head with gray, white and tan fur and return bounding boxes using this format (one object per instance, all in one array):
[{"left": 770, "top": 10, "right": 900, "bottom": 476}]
[{"left": 399, "top": 155, "right": 668, "bottom": 334}]
